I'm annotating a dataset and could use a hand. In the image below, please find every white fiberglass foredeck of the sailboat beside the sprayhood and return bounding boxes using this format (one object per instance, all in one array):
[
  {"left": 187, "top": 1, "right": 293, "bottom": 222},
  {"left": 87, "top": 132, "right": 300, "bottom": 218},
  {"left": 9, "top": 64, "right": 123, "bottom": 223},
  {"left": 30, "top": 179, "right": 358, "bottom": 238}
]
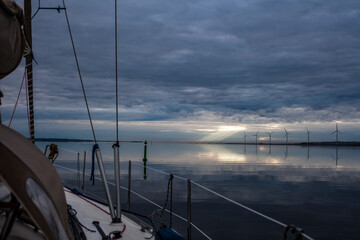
[{"left": 65, "top": 189, "right": 151, "bottom": 240}]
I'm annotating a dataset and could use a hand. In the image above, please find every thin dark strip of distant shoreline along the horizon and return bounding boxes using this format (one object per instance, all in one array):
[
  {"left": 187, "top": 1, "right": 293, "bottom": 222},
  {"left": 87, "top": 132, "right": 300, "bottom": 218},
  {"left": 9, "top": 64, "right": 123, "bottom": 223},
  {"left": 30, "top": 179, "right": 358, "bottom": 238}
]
[{"left": 35, "top": 138, "right": 360, "bottom": 147}]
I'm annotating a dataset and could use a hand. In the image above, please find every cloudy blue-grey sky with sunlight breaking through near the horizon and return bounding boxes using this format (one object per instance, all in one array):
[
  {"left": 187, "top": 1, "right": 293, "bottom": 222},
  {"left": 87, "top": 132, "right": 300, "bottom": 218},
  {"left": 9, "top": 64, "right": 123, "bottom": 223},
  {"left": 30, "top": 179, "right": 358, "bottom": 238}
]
[{"left": 0, "top": 0, "right": 360, "bottom": 141}]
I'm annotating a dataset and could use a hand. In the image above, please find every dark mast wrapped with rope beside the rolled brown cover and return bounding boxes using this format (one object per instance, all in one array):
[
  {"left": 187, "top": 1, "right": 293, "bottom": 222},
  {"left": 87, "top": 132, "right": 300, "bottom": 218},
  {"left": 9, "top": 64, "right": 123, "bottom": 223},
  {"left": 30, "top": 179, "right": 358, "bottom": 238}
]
[{"left": 24, "top": 0, "right": 35, "bottom": 143}]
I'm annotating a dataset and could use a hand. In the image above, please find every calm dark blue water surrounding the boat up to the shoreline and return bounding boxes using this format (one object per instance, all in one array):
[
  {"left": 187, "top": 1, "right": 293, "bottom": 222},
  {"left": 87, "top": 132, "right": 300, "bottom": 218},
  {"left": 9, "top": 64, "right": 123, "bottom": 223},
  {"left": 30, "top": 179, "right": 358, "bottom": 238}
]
[{"left": 38, "top": 143, "right": 360, "bottom": 239}]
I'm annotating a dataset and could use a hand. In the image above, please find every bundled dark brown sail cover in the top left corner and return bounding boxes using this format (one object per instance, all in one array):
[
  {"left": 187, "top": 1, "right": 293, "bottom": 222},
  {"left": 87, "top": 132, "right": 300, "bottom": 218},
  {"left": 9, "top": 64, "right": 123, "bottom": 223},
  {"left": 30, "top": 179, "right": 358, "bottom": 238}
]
[{"left": 0, "top": 0, "right": 25, "bottom": 79}]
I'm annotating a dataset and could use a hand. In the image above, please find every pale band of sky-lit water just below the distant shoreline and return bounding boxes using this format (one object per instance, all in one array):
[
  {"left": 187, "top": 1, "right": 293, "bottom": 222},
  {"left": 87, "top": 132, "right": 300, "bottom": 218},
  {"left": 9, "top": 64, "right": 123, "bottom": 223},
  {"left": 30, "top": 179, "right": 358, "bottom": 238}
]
[{"left": 38, "top": 143, "right": 360, "bottom": 169}]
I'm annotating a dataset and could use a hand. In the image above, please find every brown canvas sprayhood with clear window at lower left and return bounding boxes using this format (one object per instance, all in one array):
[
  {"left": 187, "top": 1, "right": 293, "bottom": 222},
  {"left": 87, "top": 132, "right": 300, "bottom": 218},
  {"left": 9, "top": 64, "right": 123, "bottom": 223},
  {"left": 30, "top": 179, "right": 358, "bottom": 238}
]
[{"left": 0, "top": 124, "right": 72, "bottom": 240}]
